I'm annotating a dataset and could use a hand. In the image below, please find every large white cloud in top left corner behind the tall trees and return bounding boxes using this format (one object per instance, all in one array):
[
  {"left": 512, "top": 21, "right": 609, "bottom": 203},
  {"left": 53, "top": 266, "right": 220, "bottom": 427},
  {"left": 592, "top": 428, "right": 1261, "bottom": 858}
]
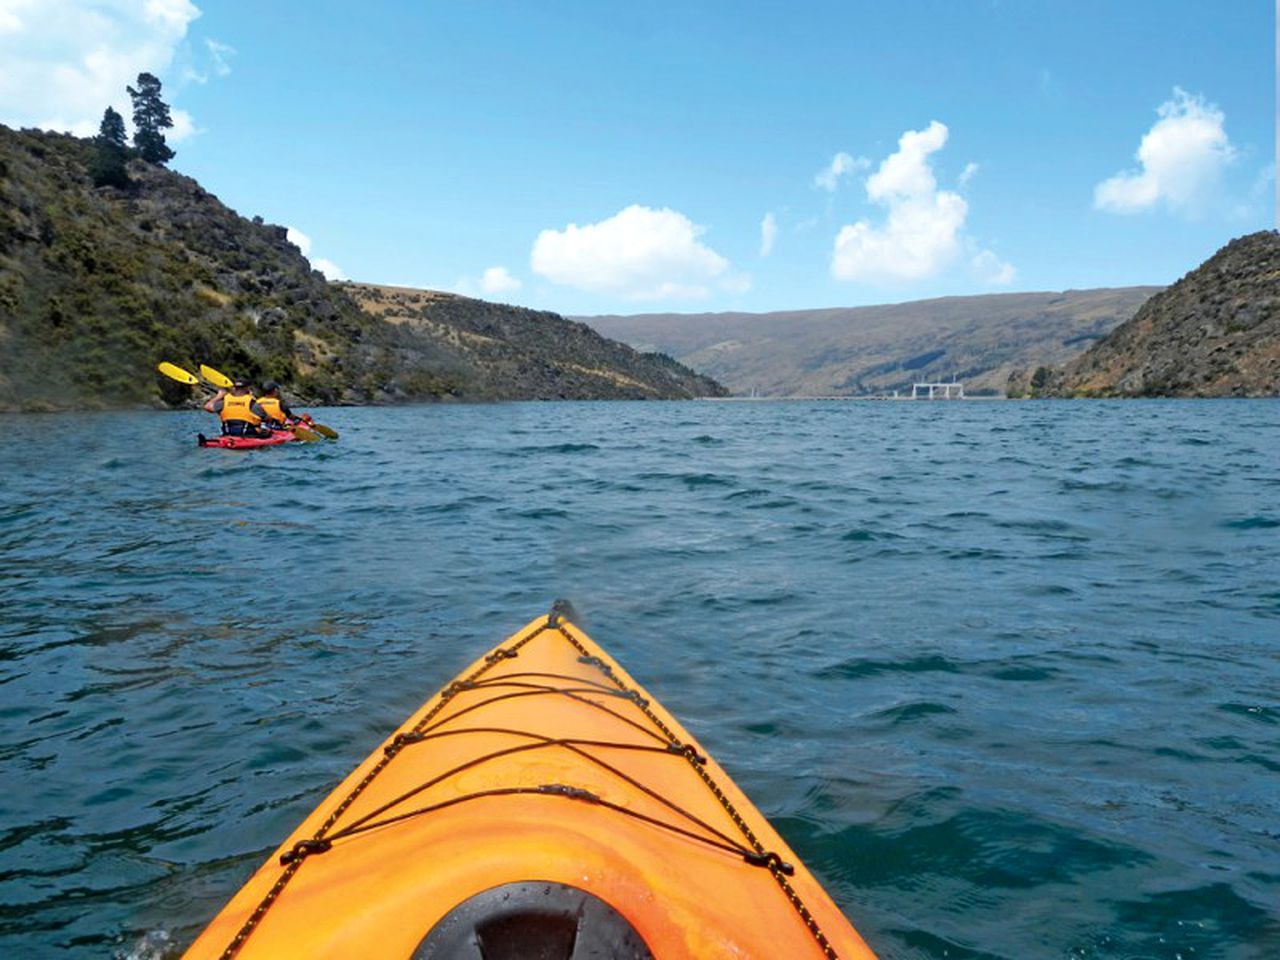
[{"left": 0, "top": 0, "right": 207, "bottom": 140}]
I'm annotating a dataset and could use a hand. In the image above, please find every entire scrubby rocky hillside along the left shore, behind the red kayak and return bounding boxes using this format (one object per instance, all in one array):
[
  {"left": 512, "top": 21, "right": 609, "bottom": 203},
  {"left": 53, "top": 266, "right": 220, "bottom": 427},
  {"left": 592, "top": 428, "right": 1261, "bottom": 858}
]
[{"left": 0, "top": 125, "right": 721, "bottom": 410}]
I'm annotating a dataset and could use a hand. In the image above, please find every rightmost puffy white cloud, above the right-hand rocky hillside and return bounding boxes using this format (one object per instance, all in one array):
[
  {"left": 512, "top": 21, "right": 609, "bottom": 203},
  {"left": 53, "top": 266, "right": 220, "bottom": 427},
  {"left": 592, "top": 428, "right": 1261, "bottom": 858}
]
[{"left": 1093, "top": 87, "right": 1235, "bottom": 215}]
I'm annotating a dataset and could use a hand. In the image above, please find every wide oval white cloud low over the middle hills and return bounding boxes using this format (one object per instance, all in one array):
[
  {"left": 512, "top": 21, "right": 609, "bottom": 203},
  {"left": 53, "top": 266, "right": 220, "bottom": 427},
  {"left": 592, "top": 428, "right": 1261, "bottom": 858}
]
[{"left": 529, "top": 205, "right": 744, "bottom": 300}]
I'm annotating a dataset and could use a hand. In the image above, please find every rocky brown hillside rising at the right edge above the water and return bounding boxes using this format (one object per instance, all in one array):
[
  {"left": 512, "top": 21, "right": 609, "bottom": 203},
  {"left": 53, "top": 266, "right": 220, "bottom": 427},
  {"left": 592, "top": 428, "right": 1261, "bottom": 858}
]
[{"left": 1025, "top": 230, "right": 1280, "bottom": 397}]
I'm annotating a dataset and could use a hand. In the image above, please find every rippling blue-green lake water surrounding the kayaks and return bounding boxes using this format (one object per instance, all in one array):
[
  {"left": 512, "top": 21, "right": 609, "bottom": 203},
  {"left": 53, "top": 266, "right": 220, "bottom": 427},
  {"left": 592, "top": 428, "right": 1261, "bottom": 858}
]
[{"left": 0, "top": 401, "right": 1280, "bottom": 960}]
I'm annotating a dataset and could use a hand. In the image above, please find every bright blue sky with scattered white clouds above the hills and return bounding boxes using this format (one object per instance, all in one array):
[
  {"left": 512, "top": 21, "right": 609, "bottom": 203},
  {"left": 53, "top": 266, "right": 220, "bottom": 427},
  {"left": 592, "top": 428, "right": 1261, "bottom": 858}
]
[{"left": 0, "top": 0, "right": 1276, "bottom": 315}]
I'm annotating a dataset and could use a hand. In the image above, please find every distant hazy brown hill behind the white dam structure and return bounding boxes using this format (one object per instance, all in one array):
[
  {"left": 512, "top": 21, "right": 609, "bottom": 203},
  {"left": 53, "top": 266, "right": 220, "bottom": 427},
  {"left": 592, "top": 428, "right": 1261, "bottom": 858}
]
[{"left": 582, "top": 287, "right": 1160, "bottom": 397}]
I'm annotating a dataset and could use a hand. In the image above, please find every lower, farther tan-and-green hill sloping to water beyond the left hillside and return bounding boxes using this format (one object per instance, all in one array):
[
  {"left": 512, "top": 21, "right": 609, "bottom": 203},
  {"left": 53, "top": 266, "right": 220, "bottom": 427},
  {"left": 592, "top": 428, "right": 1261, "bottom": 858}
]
[{"left": 342, "top": 283, "right": 727, "bottom": 399}]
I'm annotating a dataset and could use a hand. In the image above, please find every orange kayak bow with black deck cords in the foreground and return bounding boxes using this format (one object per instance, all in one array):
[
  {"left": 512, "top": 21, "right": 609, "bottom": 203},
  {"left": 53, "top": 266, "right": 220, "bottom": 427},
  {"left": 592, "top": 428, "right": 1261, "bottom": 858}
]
[{"left": 187, "top": 609, "right": 873, "bottom": 960}]
